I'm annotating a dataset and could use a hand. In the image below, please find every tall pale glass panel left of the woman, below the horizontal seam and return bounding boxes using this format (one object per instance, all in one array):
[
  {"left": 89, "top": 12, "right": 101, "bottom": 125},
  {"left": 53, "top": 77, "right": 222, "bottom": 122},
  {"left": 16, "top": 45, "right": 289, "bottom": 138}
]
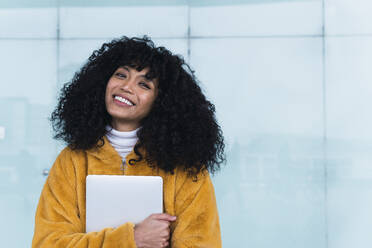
[{"left": 0, "top": 40, "right": 56, "bottom": 247}]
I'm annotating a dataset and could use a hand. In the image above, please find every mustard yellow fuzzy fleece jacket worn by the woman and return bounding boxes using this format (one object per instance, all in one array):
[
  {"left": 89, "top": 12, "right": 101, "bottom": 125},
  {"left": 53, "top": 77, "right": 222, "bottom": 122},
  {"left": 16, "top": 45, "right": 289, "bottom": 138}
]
[{"left": 32, "top": 137, "right": 221, "bottom": 248}]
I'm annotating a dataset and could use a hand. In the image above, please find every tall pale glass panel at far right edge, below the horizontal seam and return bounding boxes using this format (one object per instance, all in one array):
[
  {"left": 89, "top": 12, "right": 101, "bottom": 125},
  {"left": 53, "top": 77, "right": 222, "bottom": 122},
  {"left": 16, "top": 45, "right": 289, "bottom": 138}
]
[{"left": 326, "top": 37, "right": 372, "bottom": 248}]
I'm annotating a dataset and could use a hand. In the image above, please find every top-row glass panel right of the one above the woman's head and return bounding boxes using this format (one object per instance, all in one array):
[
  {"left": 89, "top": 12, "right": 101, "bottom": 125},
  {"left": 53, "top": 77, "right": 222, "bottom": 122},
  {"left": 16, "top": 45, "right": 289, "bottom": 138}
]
[{"left": 190, "top": 1, "right": 322, "bottom": 36}]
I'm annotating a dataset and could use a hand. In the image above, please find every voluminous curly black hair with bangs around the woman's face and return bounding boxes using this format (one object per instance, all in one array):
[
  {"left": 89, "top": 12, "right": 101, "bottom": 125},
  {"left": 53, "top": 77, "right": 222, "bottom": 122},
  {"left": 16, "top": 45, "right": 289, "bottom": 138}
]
[{"left": 50, "top": 36, "right": 226, "bottom": 176}]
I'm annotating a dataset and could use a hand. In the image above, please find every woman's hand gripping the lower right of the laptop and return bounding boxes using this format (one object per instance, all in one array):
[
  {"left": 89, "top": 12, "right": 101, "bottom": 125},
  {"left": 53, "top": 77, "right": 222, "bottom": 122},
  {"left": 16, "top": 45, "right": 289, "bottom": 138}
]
[{"left": 134, "top": 213, "right": 176, "bottom": 248}]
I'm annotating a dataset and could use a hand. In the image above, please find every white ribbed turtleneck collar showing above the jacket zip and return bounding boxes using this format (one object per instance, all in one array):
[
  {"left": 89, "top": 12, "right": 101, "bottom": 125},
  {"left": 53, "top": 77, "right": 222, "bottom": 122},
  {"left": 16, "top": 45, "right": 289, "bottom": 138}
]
[{"left": 106, "top": 126, "right": 140, "bottom": 161}]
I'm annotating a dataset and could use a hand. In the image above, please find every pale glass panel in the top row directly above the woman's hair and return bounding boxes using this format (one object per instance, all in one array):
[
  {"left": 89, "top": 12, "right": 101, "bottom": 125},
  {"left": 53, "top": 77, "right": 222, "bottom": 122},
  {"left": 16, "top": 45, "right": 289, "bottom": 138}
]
[{"left": 60, "top": 6, "right": 187, "bottom": 38}]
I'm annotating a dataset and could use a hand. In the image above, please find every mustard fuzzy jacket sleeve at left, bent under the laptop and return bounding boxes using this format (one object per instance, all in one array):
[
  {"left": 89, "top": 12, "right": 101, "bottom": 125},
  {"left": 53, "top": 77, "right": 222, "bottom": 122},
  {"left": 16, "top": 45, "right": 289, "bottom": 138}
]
[{"left": 32, "top": 149, "right": 136, "bottom": 248}]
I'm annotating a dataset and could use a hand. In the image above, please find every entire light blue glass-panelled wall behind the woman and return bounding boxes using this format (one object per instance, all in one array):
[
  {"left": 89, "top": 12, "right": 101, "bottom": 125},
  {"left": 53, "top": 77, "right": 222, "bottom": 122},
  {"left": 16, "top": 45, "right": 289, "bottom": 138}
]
[{"left": 0, "top": 0, "right": 372, "bottom": 248}]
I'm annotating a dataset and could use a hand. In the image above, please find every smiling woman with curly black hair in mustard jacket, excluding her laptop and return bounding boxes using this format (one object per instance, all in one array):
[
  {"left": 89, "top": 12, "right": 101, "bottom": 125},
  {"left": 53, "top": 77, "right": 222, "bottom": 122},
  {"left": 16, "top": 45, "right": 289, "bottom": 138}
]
[{"left": 32, "top": 36, "right": 225, "bottom": 248}]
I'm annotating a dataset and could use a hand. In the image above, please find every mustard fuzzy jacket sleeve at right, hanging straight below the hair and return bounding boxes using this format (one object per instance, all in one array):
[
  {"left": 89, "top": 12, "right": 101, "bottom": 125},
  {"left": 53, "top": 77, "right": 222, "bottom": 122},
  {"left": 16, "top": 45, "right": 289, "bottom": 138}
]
[{"left": 171, "top": 172, "right": 222, "bottom": 248}]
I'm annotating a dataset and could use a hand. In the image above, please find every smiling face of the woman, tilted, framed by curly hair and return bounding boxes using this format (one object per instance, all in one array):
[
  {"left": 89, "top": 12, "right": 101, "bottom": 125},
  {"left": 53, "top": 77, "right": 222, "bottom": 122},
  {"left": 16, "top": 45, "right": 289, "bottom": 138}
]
[{"left": 105, "top": 66, "right": 158, "bottom": 131}]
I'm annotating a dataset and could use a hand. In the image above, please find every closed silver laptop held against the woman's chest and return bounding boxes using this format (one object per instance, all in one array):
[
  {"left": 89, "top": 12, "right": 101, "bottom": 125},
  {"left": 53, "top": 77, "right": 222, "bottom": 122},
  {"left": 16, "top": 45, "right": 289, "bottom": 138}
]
[{"left": 86, "top": 175, "right": 163, "bottom": 232}]
